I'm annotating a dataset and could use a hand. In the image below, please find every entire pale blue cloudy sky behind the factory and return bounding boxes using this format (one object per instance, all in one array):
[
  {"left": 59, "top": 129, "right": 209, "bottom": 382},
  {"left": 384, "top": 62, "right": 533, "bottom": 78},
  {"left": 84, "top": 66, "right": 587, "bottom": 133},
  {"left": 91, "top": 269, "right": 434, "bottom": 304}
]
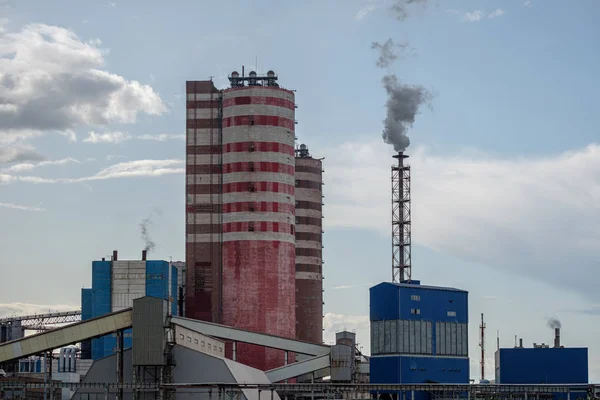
[{"left": 0, "top": 0, "right": 600, "bottom": 382}]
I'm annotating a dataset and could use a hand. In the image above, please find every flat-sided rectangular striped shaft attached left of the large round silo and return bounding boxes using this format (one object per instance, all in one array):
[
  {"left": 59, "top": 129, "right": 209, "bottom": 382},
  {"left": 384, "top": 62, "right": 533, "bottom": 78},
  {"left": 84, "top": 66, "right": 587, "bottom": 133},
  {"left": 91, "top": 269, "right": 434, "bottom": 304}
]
[{"left": 185, "top": 81, "right": 222, "bottom": 322}]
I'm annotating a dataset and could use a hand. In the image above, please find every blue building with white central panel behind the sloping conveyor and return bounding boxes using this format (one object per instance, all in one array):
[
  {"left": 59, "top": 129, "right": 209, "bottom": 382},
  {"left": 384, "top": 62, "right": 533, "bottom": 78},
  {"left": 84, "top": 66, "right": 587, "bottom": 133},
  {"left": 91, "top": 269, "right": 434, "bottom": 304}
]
[{"left": 81, "top": 260, "right": 181, "bottom": 360}]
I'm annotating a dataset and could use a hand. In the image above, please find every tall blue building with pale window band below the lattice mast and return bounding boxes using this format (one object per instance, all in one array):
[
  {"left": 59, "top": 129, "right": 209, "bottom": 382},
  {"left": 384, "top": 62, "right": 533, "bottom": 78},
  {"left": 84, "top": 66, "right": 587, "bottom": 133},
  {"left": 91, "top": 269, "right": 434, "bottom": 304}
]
[{"left": 370, "top": 280, "right": 469, "bottom": 399}]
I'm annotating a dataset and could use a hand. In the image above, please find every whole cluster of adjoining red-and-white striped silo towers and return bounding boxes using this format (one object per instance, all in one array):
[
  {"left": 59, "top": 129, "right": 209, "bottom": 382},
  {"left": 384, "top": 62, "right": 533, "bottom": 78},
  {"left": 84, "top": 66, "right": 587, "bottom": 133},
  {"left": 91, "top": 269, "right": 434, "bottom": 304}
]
[{"left": 185, "top": 69, "right": 322, "bottom": 370}]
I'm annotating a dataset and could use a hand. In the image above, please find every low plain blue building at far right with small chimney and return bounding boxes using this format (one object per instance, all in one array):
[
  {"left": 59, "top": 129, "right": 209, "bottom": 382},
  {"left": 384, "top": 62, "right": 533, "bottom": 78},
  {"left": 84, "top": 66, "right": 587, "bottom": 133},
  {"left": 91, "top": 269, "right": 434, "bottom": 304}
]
[{"left": 495, "top": 346, "right": 589, "bottom": 400}]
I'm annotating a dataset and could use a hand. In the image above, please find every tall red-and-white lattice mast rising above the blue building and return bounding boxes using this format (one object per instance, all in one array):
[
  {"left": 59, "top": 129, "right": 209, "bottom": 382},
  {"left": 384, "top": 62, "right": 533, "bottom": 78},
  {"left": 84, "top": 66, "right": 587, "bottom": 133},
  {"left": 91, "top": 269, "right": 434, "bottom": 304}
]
[{"left": 392, "top": 152, "right": 411, "bottom": 283}]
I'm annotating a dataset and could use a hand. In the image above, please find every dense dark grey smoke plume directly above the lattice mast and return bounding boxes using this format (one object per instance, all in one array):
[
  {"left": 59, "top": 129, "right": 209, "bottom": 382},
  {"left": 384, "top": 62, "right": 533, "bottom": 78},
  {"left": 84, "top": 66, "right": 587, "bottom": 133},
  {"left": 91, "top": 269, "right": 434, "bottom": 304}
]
[{"left": 382, "top": 75, "right": 432, "bottom": 152}]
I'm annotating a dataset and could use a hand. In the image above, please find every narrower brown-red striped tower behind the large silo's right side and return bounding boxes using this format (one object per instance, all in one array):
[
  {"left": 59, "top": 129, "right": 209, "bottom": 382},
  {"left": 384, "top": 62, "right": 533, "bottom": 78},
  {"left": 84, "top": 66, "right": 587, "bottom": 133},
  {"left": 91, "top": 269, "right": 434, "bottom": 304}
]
[{"left": 296, "top": 144, "right": 323, "bottom": 343}]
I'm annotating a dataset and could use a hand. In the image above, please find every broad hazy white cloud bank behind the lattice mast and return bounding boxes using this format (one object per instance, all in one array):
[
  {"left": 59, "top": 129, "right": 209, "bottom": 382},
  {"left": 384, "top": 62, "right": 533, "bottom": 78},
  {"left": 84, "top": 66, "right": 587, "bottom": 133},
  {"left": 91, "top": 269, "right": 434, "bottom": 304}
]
[{"left": 324, "top": 141, "right": 600, "bottom": 300}]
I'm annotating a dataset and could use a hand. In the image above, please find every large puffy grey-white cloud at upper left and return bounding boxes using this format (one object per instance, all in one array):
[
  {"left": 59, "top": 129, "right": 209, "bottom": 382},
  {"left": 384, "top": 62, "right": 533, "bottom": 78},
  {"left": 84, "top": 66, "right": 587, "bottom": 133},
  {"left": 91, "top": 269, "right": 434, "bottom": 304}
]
[{"left": 0, "top": 24, "right": 167, "bottom": 143}]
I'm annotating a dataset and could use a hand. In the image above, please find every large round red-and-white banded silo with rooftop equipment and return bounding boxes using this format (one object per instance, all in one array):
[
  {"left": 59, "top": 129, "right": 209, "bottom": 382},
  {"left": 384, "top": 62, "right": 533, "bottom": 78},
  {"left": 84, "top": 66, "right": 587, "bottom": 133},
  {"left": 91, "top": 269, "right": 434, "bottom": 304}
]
[{"left": 222, "top": 71, "right": 296, "bottom": 370}]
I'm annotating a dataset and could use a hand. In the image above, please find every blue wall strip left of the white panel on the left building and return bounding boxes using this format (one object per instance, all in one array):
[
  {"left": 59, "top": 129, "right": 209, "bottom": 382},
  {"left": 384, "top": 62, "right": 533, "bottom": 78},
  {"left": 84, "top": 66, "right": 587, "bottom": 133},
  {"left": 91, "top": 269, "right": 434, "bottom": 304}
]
[{"left": 92, "top": 261, "right": 112, "bottom": 360}]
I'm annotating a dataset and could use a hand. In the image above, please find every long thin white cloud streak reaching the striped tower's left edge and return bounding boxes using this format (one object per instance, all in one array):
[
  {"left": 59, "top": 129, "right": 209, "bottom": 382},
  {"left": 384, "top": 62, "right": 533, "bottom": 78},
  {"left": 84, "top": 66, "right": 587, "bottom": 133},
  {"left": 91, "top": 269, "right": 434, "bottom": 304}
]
[{"left": 0, "top": 160, "right": 185, "bottom": 184}]
